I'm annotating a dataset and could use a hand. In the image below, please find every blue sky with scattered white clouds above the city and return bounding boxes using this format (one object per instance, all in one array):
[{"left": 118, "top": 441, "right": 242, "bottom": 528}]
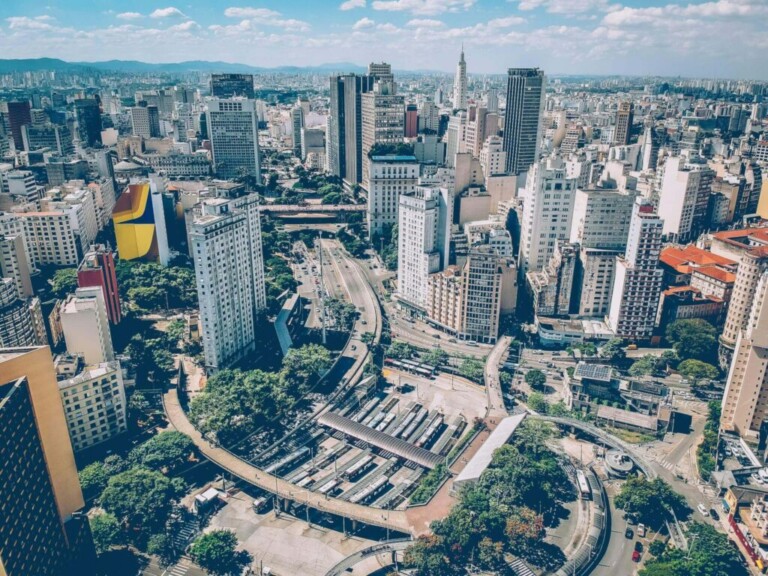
[{"left": 0, "top": 0, "right": 768, "bottom": 80}]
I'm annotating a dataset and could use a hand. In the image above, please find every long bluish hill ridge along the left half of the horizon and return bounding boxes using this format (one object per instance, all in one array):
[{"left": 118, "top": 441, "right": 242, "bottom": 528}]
[{"left": 0, "top": 58, "right": 367, "bottom": 74}]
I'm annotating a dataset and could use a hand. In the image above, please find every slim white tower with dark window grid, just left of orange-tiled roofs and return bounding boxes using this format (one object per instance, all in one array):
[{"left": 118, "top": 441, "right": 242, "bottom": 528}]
[{"left": 608, "top": 198, "right": 664, "bottom": 341}]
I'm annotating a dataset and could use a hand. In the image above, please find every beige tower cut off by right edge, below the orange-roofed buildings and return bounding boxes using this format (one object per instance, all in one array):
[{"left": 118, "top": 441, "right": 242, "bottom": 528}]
[{"left": 720, "top": 272, "right": 768, "bottom": 439}]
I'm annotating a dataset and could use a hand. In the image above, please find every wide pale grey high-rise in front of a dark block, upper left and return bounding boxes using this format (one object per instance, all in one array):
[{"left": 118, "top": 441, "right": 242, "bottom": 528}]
[{"left": 205, "top": 98, "right": 261, "bottom": 184}]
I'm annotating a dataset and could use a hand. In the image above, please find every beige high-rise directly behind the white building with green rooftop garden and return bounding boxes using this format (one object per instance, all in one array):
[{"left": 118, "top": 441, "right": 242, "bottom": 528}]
[{"left": 360, "top": 79, "right": 405, "bottom": 190}]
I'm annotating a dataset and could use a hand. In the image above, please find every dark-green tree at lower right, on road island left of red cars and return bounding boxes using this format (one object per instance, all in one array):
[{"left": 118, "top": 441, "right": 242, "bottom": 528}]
[{"left": 616, "top": 476, "right": 691, "bottom": 528}]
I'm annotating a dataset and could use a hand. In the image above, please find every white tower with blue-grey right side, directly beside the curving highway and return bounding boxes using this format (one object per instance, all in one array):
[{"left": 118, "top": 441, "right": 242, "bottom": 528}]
[{"left": 397, "top": 186, "right": 453, "bottom": 311}]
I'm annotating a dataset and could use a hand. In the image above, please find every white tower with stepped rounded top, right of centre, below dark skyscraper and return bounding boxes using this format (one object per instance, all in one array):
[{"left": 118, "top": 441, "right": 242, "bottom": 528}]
[{"left": 519, "top": 156, "right": 576, "bottom": 274}]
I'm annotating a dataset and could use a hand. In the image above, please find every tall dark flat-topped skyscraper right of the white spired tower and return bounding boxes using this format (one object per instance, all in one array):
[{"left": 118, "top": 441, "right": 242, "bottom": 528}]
[{"left": 504, "top": 68, "right": 545, "bottom": 174}]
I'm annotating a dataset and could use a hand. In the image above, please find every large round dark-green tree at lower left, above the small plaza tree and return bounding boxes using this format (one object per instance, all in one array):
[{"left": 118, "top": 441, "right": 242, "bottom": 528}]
[{"left": 100, "top": 468, "right": 184, "bottom": 537}]
